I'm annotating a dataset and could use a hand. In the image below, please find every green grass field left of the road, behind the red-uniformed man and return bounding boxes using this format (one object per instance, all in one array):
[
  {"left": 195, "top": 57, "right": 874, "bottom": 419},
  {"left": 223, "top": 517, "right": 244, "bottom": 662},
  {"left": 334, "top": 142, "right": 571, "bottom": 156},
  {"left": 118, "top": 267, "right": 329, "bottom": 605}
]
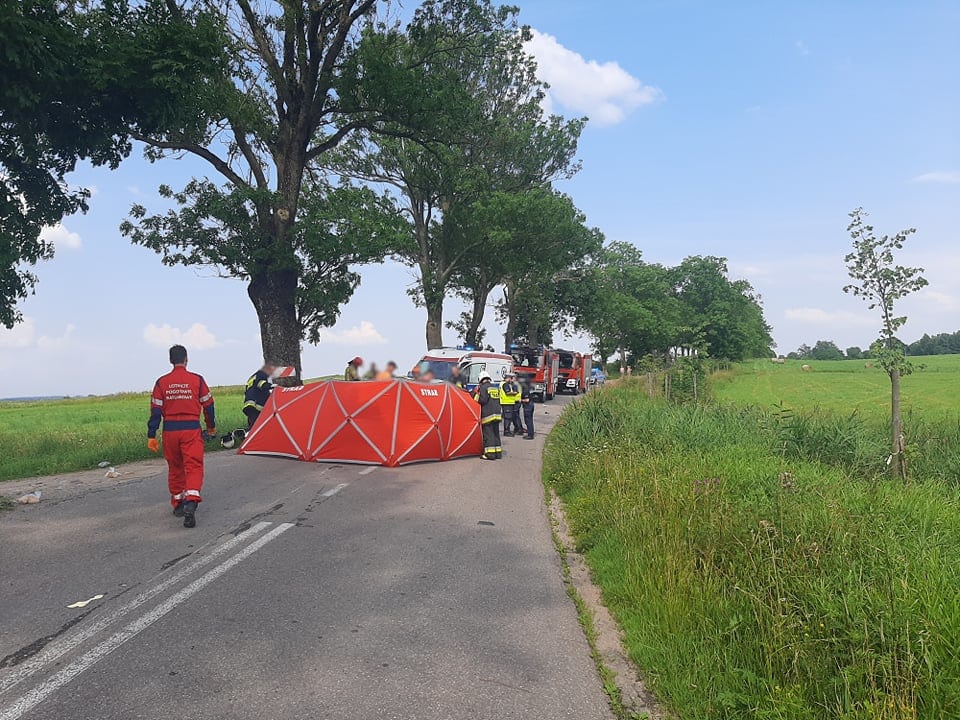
[{"left": 0, "top": 387, "right": 247, "bottom": 480}]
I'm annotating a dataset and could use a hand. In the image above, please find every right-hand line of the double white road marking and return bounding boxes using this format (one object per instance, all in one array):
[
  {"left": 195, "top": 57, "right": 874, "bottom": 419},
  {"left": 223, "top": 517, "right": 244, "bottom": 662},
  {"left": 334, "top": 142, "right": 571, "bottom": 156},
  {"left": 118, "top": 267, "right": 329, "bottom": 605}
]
[{"left": 0, "top": 523, "right": 294, "bottom": 720}]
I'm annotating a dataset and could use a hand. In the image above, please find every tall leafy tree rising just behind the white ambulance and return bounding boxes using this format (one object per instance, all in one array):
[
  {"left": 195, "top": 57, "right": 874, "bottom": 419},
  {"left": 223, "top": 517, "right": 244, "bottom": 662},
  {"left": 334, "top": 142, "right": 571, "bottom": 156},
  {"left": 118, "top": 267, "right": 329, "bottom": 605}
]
[{"left": 330, "top": 0, "right": 583, "bottom": 347}]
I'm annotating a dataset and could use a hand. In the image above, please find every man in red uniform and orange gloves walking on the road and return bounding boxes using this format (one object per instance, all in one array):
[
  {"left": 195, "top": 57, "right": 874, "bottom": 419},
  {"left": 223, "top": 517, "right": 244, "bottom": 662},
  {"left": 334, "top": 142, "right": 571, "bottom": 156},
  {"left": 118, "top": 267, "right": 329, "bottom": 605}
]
[{"left": 147, "top": 345, "right": 217, "bottom": 527}]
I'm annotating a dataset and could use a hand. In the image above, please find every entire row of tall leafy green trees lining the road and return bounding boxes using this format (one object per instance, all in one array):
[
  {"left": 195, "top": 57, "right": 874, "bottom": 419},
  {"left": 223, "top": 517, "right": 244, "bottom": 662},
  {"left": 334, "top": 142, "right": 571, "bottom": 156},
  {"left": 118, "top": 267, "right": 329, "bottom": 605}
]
[{"left": 0, "top": 0, "right": 770, "bottom": 370}]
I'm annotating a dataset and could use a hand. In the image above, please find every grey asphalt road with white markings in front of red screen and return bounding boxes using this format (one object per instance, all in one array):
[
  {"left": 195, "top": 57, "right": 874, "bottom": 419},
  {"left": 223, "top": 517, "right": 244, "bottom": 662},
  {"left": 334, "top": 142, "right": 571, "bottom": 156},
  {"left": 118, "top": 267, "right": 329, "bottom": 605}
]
[{"left": 0, "top": 401, "right": 611, "bottom": 720}]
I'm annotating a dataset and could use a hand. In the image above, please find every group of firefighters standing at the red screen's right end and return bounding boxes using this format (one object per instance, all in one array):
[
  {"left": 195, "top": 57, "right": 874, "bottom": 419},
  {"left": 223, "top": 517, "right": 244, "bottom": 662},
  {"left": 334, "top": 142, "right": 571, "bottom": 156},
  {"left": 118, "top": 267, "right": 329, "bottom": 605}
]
[{"left": 473, "top": 372, "right": 535, "bottom": 460}]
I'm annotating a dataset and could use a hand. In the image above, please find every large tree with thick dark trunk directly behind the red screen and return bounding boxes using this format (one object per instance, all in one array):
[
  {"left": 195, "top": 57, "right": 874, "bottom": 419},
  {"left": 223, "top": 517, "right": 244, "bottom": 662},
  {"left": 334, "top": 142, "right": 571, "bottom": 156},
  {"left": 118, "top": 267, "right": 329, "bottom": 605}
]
[{"left": 123, "top": 0, "right": 415, "bottom": 375}]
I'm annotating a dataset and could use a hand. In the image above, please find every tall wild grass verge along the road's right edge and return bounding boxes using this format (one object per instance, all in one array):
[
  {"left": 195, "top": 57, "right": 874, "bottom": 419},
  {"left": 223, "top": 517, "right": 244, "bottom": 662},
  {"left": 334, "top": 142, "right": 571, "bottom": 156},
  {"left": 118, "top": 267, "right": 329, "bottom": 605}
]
[{"left": 544, "top": 382, "right": 960, "bottom": 720}]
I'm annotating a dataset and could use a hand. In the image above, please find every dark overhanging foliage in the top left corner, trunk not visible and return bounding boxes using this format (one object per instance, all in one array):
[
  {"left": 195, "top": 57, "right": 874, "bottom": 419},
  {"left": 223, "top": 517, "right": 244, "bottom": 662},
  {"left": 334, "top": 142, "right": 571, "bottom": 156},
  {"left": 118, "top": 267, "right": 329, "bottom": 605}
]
[{"left": 0, "top": 0, "right": 223, "bottom": 327}]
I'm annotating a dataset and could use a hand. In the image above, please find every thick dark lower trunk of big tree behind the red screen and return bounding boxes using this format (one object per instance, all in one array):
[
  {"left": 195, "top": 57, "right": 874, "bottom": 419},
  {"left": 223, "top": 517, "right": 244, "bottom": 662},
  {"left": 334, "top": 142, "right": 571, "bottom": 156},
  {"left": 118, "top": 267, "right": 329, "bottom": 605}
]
[{"left": 247, "top": 270, "right": 303, "bottom": 385}]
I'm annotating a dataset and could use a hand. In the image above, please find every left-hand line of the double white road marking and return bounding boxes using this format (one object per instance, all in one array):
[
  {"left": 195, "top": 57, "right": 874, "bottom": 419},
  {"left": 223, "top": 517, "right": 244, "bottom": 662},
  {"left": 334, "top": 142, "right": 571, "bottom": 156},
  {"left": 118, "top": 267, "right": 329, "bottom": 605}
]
[{"left": 0, "top": 522, "right": 272, "bottom": 694}]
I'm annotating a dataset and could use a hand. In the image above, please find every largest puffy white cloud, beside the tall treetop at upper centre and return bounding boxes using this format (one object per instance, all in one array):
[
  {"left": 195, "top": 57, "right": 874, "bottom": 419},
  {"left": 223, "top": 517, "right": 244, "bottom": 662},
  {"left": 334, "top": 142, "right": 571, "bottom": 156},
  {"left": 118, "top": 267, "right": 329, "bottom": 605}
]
[{"left": 527, "top": 30, "right": 663, "bottom": 125}]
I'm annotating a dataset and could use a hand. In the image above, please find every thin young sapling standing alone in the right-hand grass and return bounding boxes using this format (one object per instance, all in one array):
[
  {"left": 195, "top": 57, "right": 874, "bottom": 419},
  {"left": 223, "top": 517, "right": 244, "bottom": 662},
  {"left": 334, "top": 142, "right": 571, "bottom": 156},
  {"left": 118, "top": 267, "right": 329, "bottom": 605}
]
[{"left": 843, "top": 208, "right": 928, "bottom": 479}]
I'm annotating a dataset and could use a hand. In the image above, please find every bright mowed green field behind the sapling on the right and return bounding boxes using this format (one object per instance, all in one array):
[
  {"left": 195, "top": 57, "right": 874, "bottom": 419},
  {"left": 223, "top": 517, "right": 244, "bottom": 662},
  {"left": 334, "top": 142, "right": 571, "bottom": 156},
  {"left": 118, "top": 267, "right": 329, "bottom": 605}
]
[{"left": 712, "top": 355, "right": 960, "bottom": 421}]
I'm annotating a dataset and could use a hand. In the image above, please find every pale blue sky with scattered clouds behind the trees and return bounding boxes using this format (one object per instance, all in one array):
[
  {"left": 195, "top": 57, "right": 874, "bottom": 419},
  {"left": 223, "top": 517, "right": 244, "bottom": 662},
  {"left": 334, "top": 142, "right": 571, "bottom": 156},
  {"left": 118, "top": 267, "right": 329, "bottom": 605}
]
[{"left": 0, "top": 0, "right": 960, "bottom": 397}]
